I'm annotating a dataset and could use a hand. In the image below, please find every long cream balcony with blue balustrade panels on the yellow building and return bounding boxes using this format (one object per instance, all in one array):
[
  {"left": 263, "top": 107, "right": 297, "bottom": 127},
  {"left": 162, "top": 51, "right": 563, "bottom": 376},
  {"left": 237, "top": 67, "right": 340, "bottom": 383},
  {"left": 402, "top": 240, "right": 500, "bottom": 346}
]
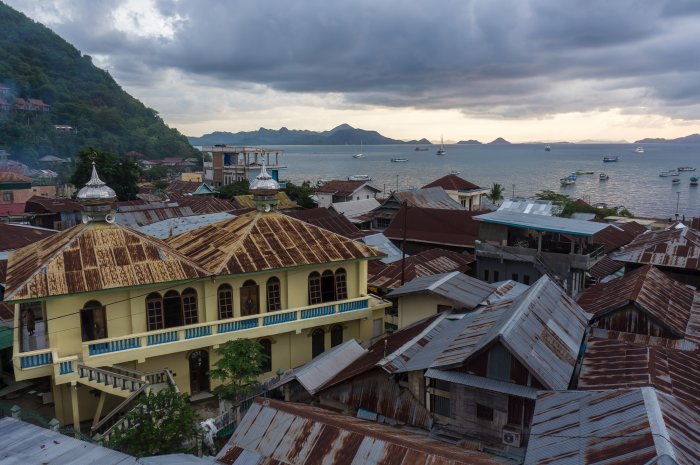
[{"left": 14, "top": 296, "right": 391, "bottom": 378}]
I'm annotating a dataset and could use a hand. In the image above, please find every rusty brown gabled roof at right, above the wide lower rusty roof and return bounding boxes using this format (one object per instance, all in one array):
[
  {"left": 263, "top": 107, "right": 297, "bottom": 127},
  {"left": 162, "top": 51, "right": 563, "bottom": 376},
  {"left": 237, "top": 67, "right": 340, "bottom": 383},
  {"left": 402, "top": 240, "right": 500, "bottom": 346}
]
[{"left": 578, "top": 265, "right": 700, "bottom": 337}]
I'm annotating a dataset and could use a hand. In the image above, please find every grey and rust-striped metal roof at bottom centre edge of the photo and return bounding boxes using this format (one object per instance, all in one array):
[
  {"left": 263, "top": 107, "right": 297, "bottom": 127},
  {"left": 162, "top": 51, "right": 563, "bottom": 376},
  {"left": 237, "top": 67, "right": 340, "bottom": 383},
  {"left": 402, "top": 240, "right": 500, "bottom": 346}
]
[{"left": 217, "top": 399, "right": 512, "bottom": 465}]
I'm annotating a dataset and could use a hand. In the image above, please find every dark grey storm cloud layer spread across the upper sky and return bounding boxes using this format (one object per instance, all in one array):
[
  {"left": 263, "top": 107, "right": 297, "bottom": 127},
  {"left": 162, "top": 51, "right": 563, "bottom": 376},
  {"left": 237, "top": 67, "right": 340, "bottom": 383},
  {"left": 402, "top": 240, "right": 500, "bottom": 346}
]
[{"left": 10, "top": 0, "right": 700, "bottom": 118}]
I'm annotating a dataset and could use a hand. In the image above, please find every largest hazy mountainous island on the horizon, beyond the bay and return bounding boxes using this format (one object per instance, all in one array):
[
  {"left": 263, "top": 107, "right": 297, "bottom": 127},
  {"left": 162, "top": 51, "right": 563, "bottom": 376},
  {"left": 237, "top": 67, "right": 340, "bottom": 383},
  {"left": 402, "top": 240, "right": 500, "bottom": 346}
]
[{"left": 188, "top": 124, "right": 431, "bottom": 145}]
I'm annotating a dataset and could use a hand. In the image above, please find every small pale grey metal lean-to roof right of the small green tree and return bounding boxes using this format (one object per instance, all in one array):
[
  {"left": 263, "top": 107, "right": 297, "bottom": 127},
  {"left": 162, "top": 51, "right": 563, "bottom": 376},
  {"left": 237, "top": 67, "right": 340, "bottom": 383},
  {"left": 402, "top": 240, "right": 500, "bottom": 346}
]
[{"left": 270, "top": 339, "right": 367, "bottom": 395}]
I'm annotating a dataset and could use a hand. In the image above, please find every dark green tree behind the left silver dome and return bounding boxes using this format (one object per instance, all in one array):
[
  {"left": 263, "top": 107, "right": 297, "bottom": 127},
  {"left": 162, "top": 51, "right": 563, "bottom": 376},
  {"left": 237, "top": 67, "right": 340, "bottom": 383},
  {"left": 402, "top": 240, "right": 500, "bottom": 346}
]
[{"left": 70, "top": 147, "right": 141, "bottom": 200}]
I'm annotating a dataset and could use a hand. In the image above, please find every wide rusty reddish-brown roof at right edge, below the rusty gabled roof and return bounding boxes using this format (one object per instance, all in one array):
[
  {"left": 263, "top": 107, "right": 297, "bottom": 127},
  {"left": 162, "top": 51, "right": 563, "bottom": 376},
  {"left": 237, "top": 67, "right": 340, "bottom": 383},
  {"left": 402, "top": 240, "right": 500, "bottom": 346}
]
[{"left": 578, "top": 337, "right": 700, "bottom": 405}]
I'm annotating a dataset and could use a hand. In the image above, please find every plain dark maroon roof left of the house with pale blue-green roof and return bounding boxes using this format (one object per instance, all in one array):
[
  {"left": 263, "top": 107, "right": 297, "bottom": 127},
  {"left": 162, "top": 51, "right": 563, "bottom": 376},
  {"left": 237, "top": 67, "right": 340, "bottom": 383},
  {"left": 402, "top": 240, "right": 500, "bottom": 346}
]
[{"left": 384, "top": 207, "right": 484, "bottom": 247}]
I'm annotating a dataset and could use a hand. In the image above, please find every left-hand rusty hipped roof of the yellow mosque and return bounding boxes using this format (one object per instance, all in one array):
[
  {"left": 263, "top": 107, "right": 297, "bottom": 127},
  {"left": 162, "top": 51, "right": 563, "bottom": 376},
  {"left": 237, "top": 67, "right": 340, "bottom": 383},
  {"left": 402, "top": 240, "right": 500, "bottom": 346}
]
[{"left": 5, "top": 223, "right": 208, "bottom": 301}]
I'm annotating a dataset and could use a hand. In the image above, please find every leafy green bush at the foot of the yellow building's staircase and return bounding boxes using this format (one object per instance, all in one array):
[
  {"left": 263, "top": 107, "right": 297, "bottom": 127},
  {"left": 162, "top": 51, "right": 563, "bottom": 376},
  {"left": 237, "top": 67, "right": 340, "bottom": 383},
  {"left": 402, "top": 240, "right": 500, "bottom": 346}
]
[{"left": 108, "top": 388, "right": 200, "bottom": 457}]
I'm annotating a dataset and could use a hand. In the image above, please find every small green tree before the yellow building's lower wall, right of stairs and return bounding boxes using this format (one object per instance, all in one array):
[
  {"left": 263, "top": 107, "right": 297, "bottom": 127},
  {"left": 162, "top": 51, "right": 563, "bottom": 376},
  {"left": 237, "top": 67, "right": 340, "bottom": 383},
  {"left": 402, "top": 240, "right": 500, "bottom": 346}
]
[{"left": 211, "top": 339, "right": 268, "bottom": 400}]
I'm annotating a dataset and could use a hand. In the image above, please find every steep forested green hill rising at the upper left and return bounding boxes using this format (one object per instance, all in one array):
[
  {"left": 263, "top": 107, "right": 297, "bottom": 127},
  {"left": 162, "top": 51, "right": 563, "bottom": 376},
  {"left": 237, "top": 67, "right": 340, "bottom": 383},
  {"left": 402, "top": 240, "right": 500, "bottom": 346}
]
[{"left": 0, "top": 3, "right": 195, "bottom": 165}]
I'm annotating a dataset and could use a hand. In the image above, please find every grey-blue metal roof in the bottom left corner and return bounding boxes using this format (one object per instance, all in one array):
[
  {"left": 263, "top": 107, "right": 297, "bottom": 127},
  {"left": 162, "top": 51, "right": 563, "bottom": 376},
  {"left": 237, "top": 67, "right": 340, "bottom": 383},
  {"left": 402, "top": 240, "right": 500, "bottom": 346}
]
[{"left": 0, "top": 418, "right": 138, "bottom": 465}]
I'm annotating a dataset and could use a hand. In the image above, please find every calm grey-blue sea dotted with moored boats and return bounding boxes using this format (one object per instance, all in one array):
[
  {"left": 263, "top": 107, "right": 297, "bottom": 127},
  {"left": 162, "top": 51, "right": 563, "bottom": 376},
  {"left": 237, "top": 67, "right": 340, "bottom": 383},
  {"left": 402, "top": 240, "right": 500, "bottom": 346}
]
[{"left": 272, "top": 143, "right": 700, "bottom": 218}]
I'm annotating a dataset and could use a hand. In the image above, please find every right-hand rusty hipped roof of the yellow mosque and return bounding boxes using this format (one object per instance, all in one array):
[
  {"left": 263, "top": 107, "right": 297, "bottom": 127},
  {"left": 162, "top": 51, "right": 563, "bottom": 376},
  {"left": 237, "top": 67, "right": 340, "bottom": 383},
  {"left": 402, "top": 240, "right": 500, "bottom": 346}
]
[{"left": 167, "top": 211, "right": 382, "bottom": 274}]
